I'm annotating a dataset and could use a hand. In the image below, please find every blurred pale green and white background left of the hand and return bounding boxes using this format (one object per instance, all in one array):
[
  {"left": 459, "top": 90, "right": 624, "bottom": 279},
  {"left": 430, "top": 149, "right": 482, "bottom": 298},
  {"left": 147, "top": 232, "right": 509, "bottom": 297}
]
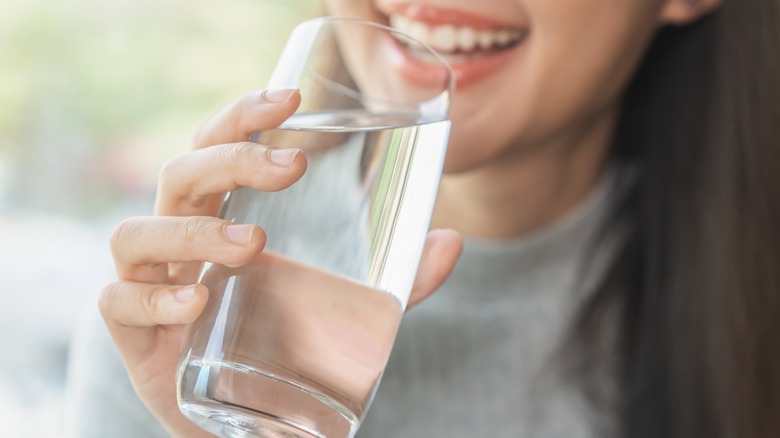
[{"left": 0, "top": 0, "right": 317, "bottom": 437}]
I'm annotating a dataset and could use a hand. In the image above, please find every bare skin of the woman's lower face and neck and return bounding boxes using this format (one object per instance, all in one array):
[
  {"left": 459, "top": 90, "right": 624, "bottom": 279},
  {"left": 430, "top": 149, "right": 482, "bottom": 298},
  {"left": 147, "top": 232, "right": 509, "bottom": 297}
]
[{"left": 326, "top": 0, "right": 718, "bottom": 239}]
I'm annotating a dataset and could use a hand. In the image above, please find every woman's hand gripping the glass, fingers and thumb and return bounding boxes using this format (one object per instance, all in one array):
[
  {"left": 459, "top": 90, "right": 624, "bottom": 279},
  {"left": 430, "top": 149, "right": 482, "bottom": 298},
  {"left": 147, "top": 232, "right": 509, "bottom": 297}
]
[{"left": 99, "top": 90, "right": 461, "bottom": 436}]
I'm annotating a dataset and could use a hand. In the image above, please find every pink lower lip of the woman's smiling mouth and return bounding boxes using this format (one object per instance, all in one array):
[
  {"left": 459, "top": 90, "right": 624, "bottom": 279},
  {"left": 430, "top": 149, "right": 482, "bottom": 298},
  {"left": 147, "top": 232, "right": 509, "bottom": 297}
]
[{"left": 387, "top": 33, "right": 525, "bottom": 90}]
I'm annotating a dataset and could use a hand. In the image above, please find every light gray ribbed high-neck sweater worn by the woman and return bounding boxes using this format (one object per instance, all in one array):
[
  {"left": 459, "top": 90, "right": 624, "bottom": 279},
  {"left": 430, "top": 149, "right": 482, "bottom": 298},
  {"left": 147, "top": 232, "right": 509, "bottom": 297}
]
[{"left": 68, "top": 173, "right": 613, "bottom": 438}]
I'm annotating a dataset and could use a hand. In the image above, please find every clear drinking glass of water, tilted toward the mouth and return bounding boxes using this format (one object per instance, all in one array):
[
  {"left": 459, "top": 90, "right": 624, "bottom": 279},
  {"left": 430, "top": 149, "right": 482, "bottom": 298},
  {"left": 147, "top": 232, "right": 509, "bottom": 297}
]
[{"left": 177, "top": 17, "right": 453, "bottom": 437}]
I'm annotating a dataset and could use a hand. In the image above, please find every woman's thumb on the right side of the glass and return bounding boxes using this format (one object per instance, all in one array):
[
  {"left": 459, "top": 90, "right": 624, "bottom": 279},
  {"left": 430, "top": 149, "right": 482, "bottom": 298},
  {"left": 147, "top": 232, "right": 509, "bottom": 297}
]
[{"left": 407, "top": 230, "right": 463, "bottom": 310}]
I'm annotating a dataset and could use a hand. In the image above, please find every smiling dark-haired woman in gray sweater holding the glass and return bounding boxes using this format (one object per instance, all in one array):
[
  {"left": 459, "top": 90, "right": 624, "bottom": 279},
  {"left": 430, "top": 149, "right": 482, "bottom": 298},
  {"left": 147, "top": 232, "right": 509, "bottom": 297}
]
[{"left": 68, "top": 0, "right": 780, "bottom": 437}]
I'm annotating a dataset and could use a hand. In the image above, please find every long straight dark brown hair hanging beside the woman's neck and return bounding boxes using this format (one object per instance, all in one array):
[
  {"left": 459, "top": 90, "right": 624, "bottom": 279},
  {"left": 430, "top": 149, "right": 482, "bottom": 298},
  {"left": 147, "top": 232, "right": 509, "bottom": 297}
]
[{"left": 572, "top": 0, "right": 780, "bottom": 438}]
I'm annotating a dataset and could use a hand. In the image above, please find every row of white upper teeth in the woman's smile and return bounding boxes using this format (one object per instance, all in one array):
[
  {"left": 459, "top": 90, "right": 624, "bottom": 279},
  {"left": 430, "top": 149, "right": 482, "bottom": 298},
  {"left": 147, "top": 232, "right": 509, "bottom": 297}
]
[{"left": 390, "top": 14, "right": 525, "bottom": 53}]
